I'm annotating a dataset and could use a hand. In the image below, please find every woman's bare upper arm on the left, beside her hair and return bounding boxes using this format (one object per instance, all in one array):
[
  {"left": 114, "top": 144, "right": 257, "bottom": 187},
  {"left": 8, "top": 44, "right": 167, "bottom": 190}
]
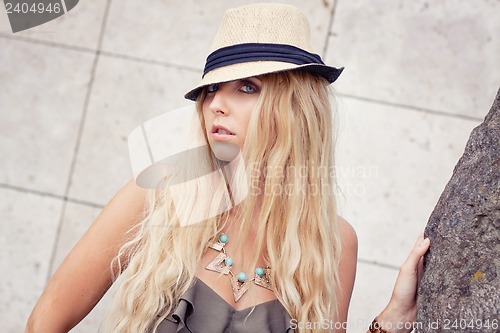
[{"left": 25, "top": 180, "right": 147, "bottom": 333}]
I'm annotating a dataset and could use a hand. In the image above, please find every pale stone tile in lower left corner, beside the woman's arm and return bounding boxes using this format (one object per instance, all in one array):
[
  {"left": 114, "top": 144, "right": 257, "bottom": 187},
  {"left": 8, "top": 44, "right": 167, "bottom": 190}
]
[{"left": 0, "top": 188, "right": 62, "bottom": 333}]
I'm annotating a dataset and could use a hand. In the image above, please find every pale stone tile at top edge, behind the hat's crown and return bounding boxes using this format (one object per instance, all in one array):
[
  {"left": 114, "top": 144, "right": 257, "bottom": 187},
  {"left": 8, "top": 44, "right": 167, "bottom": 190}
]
[{"left": 103, "top": 0, "right": 333, "bottom": 72}]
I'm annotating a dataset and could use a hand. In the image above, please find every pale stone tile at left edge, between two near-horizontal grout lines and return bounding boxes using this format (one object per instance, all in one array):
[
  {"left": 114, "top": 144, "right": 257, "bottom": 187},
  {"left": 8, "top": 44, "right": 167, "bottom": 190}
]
[{"left": 0, "top": 38, "right": 94, "bottom": 195}]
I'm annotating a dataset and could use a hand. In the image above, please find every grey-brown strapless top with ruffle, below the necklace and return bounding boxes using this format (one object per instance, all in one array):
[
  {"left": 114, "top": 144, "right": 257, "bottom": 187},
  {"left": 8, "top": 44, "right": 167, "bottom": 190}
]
[{"left": 157, "top": 279, "right": 295, "bottom": 333}]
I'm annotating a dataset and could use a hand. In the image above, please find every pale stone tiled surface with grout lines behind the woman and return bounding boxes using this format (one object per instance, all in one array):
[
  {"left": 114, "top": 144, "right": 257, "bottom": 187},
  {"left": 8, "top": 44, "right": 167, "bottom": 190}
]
[{"left": 0, "top": 0, "right": 500, "bottom": 332}]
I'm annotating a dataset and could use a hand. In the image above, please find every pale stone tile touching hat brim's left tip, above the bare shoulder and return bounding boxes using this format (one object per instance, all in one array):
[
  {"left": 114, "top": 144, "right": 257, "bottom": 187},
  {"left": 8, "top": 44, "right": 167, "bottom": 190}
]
[{"left": 70, "top": 56, "right": 199, "bottom": 205}]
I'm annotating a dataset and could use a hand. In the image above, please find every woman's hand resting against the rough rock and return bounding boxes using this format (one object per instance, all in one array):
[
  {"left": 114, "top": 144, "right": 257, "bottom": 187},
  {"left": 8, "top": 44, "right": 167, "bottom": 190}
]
[{"left": 377, "top": 234, "right": 430, "bottom": 333}]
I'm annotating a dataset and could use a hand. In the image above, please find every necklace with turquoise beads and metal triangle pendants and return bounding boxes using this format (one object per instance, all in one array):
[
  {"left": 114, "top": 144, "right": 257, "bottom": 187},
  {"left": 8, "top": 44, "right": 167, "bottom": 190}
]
[{"left": 205, "top": 234, "right": 273, "bottom": 302}]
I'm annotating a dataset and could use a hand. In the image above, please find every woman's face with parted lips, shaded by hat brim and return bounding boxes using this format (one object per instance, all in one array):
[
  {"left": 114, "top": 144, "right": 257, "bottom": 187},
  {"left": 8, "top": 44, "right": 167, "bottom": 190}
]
[{"left": 202, "top": 77, "right": 262, "bottom": 150}]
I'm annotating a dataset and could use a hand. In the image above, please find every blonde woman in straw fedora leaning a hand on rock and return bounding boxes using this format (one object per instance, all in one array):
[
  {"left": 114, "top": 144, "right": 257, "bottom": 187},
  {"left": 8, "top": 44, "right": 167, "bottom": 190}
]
[{"left": 27, "top": 4, "right": 429, "bottom": 333}]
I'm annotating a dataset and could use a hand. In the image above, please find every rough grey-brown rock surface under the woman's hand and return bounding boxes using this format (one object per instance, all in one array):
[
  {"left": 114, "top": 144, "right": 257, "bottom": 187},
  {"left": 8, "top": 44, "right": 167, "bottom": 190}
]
[{"left": 416, "top": 90, "right": 500, "bottom": 333}]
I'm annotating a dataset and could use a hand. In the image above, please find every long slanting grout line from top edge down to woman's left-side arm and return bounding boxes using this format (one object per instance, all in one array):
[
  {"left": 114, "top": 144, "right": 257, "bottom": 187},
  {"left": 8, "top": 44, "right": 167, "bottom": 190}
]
[{"left": 47, "top": 0, "right": 111, "bottom": 282}]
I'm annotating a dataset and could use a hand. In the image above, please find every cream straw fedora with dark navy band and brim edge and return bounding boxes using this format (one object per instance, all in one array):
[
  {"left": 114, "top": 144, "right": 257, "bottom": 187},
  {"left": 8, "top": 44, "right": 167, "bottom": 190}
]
[{"left": 184, "top": 3, "right": 344, "bottom": 101}]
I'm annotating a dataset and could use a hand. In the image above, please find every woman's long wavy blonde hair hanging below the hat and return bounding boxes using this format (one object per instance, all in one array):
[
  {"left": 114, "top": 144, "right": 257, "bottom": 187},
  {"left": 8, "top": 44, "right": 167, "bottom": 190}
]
[{"left": 106, "top": 71, "right": 340, "bottom": 332}]
